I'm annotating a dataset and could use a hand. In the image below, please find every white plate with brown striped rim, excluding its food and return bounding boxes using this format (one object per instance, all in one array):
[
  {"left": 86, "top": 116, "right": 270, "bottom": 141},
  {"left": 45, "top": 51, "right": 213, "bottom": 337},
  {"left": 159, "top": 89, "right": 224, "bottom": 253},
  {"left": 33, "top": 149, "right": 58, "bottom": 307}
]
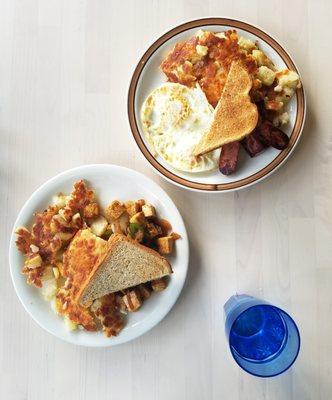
[{"left": 128, "top": 18, "right": 305, "bottom": 192}]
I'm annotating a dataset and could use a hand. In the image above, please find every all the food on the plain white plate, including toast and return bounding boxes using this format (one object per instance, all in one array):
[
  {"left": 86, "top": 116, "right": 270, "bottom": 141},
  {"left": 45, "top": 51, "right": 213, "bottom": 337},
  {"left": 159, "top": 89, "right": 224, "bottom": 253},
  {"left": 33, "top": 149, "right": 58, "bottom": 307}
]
[{"left": 16, "top": 181, "right": 180, "bottom": 337}]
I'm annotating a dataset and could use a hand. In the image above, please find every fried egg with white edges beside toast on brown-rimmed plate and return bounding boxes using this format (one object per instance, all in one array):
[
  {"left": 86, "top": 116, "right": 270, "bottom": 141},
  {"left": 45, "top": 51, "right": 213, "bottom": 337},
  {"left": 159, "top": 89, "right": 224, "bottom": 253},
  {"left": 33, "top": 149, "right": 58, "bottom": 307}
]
[{"left": 141, "top": 83, "right": 219, "bottom": 172}]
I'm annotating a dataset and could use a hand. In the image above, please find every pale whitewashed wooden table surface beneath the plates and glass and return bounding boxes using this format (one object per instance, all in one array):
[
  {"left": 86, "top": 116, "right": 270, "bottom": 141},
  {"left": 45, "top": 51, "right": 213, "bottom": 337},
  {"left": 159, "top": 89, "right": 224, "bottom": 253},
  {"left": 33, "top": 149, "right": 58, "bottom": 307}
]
[{"left": 0, "top": 0, "right": 332, "bottom": 400}]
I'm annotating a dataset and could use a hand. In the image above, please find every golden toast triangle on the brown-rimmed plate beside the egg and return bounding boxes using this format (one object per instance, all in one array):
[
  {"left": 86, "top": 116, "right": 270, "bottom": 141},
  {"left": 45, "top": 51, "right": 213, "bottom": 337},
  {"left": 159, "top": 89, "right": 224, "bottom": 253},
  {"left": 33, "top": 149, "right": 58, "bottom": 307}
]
[{"left": 194, "top": 62, "right": 258, "bottom": 156}]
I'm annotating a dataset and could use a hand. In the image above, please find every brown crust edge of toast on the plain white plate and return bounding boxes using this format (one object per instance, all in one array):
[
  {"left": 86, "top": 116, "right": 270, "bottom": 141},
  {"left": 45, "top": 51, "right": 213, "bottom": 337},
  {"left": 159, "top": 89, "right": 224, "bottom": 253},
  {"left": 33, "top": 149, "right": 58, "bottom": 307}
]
[{"left": 76, "top": 233, "right": 173, "bottom": 306}]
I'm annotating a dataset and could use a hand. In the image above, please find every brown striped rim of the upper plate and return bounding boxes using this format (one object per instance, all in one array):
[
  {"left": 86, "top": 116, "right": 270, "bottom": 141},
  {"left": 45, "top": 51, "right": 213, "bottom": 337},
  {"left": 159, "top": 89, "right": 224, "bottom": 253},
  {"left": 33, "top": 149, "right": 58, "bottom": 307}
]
[{"left": 128, "top": 18, "right": 305, "bottom": 192}]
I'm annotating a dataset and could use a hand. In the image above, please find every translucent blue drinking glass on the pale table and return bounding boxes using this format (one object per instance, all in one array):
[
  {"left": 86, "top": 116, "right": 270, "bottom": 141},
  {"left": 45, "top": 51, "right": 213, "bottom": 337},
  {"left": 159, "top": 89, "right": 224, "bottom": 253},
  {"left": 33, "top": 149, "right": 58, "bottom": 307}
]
[{"left": 224, "top": 294, "right": 300, "bottom": 378}]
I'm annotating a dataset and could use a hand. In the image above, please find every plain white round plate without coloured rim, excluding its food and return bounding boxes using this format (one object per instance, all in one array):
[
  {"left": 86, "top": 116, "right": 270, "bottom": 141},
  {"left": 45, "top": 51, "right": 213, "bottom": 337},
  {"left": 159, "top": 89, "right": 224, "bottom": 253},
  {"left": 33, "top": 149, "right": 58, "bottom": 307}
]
[{"left": 9, "top": 164, "right": 189, "bottom": 347}]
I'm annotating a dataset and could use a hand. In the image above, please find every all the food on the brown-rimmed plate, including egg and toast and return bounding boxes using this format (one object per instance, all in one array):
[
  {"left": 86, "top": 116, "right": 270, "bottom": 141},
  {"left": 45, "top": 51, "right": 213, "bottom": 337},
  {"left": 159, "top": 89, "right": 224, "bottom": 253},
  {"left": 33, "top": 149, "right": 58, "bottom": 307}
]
[{"left": 141, "top": 30, "right": 301, "bottom": 175}]
